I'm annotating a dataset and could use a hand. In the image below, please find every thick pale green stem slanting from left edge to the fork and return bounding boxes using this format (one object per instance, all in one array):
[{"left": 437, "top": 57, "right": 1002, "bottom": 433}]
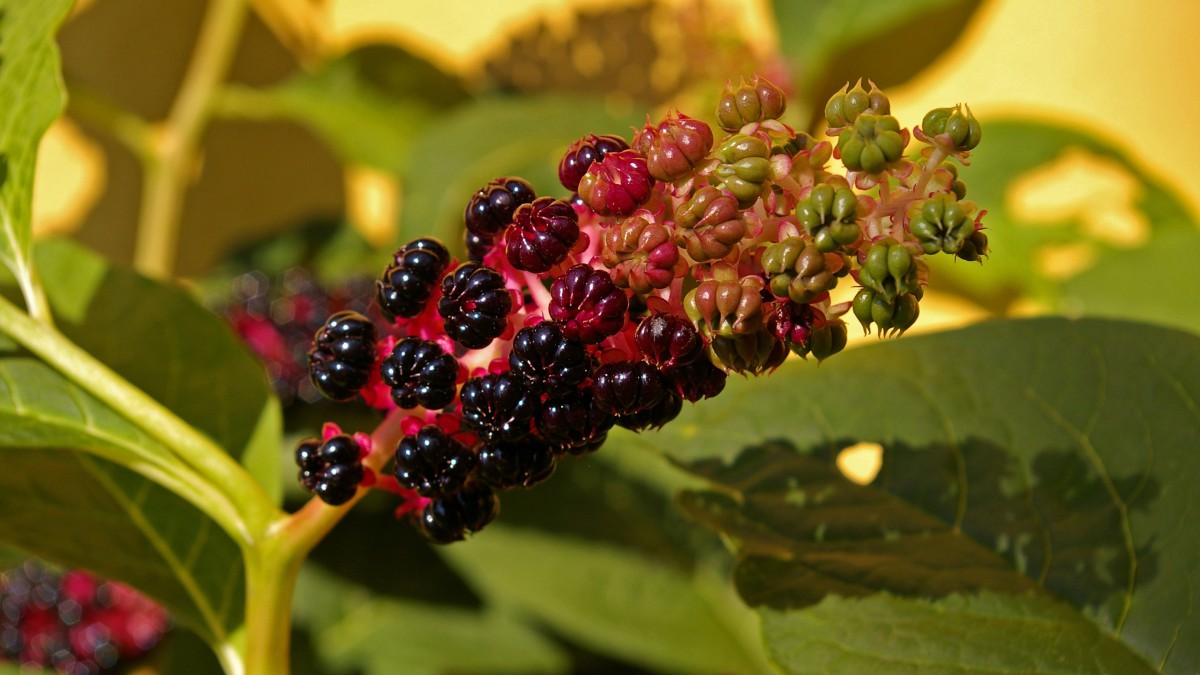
[{"left": 0, "top": 297, "right": 278, "bottom": 540}]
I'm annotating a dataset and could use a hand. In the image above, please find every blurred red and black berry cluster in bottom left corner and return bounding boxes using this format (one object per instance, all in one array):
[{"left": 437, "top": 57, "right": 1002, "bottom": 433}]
[{"left": 0, "top": 560, "right": 168, "bottom": 675}]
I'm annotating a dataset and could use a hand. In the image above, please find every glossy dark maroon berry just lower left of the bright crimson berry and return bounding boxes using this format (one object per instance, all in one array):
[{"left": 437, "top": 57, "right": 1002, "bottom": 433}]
[{"left": 504, "top": 197, "right": 580, "bottom": 274}]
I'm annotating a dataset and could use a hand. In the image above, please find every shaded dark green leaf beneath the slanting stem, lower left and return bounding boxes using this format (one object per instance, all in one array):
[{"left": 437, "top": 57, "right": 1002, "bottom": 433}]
[{"left": 0, "top": 446, "right": 242, "bottom": 645}]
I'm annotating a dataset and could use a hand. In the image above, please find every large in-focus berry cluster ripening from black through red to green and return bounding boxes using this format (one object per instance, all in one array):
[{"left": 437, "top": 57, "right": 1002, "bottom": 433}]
[{"left": 298, "top": 77, "right": 988, "bottom": 543}]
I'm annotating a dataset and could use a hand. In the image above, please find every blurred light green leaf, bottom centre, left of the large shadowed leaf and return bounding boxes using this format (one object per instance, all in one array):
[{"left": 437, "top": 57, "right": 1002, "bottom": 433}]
[{"left": 443, "top": 524, "right": 757, "bottom": 673}]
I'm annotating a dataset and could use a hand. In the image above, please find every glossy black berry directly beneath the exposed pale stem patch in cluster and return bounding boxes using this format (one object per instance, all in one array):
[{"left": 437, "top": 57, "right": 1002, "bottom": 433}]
[{"left": 458, "top": 372, "right": 540, "bottom": 442}]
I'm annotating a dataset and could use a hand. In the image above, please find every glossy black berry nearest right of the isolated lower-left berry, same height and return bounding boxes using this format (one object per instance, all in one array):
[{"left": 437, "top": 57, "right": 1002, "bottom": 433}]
[{"left": 395, "top": 425, "right": 475, "bottom": 498}]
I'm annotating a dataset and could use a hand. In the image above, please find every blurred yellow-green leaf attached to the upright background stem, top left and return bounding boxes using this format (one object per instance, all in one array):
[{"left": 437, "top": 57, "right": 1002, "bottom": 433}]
[{"left": 222, "top": 44, "right": 468, "bottom": 172}]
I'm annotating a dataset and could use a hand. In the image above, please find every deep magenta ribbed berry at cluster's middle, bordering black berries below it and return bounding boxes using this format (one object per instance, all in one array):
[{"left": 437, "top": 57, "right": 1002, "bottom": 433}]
[{"left": 550, "top": 264, "right": 629, "bottom": 345}]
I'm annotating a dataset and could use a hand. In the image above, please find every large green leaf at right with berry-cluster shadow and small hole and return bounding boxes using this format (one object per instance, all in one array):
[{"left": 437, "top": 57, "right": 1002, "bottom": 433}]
[{"left": 640, "top": 318, "right": 1200, "bottom": 673}]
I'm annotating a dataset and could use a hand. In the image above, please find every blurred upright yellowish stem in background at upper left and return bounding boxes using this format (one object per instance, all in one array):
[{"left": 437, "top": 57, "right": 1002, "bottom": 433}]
[{"left": 133, "top": 0, "right": 246, "bottom": 279}]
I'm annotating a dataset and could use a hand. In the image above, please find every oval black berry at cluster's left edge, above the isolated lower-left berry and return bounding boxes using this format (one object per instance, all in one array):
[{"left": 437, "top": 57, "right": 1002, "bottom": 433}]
[{"left": 308, "top": 311, "right": 376, "bottom": 401}]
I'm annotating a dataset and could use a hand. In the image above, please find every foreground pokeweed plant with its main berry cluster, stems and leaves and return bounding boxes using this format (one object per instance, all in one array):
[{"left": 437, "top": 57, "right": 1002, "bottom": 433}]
[{"left": 0, "top": 0, "right": 1200, "bottom": 674}]
